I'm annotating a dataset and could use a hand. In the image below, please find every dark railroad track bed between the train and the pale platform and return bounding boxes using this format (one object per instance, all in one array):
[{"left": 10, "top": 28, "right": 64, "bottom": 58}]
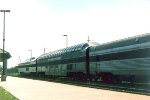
[{"left": 16, "top": 77, "right": 150, "bottom": 96}]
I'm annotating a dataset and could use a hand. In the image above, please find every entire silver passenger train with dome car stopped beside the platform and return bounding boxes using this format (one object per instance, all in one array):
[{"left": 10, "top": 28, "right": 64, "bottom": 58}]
[{"left": 16, "top": 33, "right": 150, "bottom": 83}]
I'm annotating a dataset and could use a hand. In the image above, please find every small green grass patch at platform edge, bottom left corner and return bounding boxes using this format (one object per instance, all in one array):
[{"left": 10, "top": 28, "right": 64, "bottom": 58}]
[{"left": 0, "top": 87, "right": 18, "bottom": 100}]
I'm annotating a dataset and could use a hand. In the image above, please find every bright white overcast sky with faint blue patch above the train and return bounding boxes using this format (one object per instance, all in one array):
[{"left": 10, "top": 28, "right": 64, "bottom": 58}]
[{"left": 0, "top": 0, "right": 150, "bottom": 68}]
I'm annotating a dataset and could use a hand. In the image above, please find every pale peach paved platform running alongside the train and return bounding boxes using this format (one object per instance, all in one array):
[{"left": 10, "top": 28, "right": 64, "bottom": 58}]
[{"left": 0, "top": 77, "right": 150, "bottom": 100}]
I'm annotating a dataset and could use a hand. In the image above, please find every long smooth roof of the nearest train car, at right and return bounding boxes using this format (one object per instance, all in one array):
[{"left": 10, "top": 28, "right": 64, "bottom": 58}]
[{"left": 91, "top": 33, "right": 150, "bottom": 50}]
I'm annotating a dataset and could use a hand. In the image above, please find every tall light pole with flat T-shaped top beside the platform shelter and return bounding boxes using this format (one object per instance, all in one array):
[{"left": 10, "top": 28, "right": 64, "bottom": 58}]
[{"left": 0, "top": 10, "right": 10, "bottom": 81}]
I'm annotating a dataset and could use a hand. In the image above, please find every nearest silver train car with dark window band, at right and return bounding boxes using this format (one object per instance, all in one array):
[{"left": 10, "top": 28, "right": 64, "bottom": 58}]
[{"left": 89, "top": 34, "right": 150, "bottom": 82}]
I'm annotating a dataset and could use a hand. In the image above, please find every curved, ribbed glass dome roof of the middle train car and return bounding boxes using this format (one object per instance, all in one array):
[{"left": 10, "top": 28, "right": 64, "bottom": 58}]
[{"left": 38, "top": 42, "right": 99, "bottom": 59}]
